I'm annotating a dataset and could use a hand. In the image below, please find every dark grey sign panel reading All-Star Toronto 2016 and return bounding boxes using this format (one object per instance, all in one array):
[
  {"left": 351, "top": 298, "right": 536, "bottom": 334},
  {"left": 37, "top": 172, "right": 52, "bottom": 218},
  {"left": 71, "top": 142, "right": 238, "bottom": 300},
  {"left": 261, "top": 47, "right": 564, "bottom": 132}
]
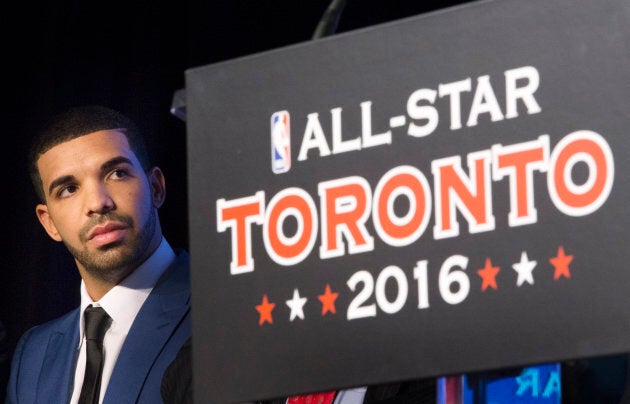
[{"left": 186, "top": 0, "right": 630, "bottom": 402}]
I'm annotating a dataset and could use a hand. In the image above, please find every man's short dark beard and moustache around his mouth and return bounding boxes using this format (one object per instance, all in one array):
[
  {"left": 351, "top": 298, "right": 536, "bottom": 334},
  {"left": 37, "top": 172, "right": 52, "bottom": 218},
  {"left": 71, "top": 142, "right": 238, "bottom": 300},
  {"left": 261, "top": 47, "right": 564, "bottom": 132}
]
[{"left": 65, "top": 209, "right": 157, "bottom": 284}]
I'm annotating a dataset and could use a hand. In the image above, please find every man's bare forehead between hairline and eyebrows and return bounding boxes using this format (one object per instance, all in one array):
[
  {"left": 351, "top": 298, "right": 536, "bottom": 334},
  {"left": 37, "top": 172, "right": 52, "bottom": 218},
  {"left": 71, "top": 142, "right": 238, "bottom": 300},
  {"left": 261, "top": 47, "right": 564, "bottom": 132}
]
[{"left": 37, "top": 130, "right": 138, "bottom": 184}]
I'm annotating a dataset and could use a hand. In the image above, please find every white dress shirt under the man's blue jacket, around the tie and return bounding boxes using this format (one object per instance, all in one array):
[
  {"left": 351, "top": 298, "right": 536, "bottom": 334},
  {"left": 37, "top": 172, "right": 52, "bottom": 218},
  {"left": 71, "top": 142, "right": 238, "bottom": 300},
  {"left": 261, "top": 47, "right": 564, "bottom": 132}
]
[{"left": 70, "top": 238, "right": 175, "bottom": 404}]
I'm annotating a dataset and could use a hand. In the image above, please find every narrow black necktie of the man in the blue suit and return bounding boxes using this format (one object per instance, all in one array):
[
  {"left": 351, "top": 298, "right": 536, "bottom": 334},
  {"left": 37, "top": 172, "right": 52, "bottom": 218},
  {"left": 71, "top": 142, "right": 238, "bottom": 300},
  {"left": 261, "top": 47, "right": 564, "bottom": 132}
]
[{"left": 79, "top": 305, "right": 112, "bottom": 404}]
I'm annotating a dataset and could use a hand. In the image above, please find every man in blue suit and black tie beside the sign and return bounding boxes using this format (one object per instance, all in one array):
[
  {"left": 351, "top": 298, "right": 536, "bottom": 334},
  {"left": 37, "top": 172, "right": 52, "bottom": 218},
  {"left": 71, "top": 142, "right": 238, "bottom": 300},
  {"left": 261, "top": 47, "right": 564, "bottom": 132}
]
[{"left": 7, "top": 107, "right": 191, "bottom": 404}]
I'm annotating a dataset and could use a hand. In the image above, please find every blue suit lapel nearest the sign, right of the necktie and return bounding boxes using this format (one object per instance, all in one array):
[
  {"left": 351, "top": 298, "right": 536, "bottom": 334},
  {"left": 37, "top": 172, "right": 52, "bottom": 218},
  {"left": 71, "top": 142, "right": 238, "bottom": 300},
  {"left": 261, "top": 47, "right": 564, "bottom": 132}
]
[{"left": 104, "top": 253, "right": 190, "bottom": 403}]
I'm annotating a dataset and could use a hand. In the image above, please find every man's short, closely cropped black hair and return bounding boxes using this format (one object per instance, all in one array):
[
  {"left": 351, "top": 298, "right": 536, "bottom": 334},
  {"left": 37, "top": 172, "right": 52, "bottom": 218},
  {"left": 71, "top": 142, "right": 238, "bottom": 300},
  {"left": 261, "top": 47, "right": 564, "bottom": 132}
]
[{"left": 28, "top": 105, "right": 151, "bottom": 203}]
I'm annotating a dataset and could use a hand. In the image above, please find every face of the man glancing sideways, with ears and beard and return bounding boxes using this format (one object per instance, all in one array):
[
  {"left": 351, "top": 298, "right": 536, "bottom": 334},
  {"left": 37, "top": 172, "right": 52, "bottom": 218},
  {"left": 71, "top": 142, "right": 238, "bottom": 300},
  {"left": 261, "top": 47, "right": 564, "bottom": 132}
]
[{"left": 36, "top": 130, "right": 164, "bottom": 283}]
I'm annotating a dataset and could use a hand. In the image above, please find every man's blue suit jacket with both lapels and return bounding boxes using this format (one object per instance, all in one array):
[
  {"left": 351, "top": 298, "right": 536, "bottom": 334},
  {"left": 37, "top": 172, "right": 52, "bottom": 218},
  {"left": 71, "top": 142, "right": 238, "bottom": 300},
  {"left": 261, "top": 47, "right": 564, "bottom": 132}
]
[{"left": 6, "top": 252, "right": 191, "bottom": 404}]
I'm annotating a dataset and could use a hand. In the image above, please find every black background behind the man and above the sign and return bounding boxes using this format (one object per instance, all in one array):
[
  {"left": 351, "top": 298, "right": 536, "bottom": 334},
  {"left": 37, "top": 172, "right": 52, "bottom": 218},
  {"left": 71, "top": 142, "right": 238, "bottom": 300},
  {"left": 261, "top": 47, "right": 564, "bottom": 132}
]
[{"left": 0, "top": 0, "right": 470, "bottom": 398}]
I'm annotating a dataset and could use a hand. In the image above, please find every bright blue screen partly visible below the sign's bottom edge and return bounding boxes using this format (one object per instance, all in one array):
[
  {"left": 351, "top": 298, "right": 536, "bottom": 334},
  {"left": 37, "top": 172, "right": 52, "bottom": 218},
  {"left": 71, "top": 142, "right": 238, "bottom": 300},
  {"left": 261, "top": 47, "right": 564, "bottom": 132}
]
[{"left": 437, "top": 363, "right": 562, "bottom": 404}]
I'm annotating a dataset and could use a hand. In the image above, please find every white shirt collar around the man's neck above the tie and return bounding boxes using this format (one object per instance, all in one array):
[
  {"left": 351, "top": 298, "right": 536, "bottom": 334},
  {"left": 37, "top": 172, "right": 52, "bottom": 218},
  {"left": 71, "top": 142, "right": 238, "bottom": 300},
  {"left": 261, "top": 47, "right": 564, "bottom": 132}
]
[{"left": 79, "top": 237, "right": 176, "bottom": 341}]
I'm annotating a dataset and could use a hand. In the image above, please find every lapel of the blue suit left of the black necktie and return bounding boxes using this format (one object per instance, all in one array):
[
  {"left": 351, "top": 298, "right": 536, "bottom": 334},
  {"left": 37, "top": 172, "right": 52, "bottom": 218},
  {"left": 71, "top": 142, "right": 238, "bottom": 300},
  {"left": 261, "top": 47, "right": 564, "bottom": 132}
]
[{"left": 37, "top": 310, "right": 79, "bottom": 403}]
